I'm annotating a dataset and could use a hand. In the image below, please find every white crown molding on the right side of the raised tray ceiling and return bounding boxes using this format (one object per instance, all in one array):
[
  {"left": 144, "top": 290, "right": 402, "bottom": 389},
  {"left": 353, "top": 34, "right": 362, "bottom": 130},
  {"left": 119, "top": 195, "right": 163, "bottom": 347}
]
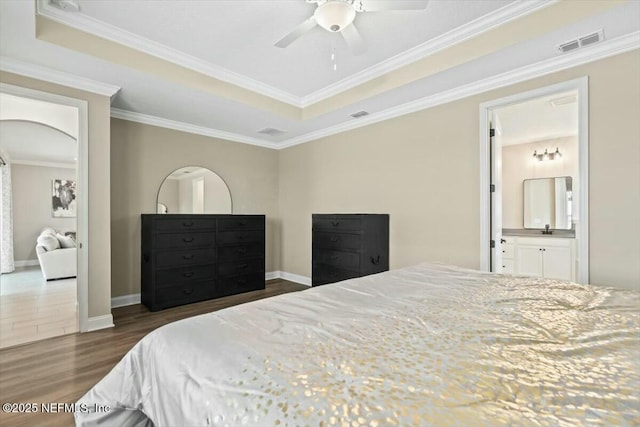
[{"left": 300, "top": 0, "right": 558, "bottom": 108}]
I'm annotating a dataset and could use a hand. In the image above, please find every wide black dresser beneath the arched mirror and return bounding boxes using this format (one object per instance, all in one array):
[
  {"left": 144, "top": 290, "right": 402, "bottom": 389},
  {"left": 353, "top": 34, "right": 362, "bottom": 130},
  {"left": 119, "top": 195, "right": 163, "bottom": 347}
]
[{"left": 141, "top": 214, "right": 265, "bottom": 311}]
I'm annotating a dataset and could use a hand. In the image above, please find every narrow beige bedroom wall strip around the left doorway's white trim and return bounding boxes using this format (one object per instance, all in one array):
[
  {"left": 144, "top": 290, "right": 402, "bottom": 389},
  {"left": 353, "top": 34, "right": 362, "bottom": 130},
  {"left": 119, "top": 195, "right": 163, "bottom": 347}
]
[{"left": 0, "top": 72, "right": 111, "bottom": 318}]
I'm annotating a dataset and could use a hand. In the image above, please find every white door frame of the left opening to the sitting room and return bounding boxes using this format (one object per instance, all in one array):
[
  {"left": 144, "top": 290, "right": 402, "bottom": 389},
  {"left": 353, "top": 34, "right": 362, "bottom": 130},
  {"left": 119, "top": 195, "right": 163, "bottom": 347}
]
[{"left": 0, "top": 83, "right": 89, "bottom": 332}]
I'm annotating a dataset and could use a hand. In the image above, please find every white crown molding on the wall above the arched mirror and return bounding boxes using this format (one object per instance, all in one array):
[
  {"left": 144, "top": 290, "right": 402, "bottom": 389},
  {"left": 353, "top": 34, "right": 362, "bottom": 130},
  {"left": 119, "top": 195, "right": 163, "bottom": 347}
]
[{"left": 111, "top": 108, "right": 277, "bottom": 148}]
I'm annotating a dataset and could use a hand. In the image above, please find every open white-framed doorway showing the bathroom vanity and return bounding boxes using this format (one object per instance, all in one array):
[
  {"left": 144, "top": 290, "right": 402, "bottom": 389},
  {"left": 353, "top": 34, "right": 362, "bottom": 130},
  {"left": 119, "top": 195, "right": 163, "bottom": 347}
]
[{"left": 480, "top": 77, "right": 589, "bottom": 283}]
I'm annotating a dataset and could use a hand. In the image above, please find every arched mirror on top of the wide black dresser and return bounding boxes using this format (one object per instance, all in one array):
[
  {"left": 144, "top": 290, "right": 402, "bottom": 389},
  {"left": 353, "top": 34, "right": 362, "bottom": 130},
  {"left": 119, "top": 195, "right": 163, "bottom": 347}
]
[{"left": 156, "top": 166, "right": 232, "bottom": 214}]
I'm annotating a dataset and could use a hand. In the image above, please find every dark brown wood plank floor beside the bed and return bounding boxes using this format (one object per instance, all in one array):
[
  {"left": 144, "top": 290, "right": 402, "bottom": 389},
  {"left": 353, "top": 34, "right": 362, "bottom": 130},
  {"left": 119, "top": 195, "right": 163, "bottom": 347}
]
[{"left": 0, "top": 280, "right": 307, "bottom": 427}]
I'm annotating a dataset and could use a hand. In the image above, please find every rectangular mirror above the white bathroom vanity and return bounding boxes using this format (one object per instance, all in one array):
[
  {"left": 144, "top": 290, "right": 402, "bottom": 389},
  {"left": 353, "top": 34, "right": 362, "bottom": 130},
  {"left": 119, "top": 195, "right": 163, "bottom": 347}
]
[{"left": 523, "top": 176, "right": 573, "bottom": 230}]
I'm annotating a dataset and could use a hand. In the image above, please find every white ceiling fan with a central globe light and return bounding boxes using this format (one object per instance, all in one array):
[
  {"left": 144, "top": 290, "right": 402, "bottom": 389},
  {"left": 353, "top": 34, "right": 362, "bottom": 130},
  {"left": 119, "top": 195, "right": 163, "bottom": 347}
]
[{"left": 275, "top": 0, "right": 428, "bottom": 55}]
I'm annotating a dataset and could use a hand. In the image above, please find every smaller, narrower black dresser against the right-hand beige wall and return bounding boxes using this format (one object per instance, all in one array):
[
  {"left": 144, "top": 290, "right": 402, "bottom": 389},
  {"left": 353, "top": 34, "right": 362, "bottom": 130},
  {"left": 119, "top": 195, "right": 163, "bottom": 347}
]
[{"left": 311, "top": 214, "right": 389, "bottom": 286}]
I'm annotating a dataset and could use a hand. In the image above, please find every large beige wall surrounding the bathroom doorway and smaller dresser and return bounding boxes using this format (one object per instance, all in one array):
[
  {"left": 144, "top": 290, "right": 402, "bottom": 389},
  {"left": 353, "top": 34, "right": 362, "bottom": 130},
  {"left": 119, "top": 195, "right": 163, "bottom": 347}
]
[{"left": 279, "top": 50, "right": 640, "bottom": 288}]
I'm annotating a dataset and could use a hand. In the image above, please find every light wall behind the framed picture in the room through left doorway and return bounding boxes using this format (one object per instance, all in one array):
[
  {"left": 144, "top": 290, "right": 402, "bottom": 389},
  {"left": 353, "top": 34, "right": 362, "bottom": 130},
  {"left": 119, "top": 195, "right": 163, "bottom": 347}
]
[{"left": 11, "top": 163, "right": 76, "bottom": 261}]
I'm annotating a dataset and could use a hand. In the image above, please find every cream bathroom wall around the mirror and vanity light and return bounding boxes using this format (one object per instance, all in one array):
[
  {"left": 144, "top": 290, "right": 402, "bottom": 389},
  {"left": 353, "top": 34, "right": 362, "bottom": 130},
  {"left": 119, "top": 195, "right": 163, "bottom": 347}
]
[{"left": 502, "top": 136, "right": 580, "bottom": 228}]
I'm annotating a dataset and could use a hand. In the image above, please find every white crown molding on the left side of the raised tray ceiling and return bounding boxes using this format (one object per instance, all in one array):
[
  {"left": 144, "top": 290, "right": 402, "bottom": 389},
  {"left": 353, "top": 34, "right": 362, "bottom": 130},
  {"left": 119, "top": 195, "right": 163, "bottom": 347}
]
[{"left": 36, "top": 0, "right": 300, "bottom": 107}]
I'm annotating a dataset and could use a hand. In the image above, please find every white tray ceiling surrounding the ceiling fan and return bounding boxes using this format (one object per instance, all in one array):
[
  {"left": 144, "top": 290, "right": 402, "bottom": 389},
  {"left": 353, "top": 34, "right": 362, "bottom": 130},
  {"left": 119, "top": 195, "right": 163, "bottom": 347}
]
[{"left": 0, "top": 0, "right": 640, "bottom": 148}]
